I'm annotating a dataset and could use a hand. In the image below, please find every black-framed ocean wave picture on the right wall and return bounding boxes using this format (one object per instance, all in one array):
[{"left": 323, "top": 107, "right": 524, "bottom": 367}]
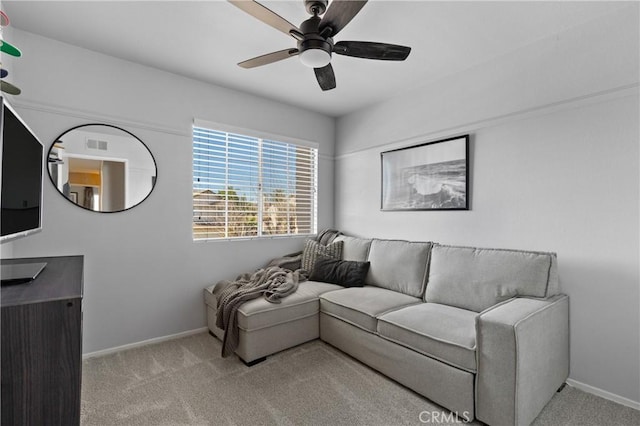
[{"left": 380, "top": 135, "right": 469, "bottom": 210}]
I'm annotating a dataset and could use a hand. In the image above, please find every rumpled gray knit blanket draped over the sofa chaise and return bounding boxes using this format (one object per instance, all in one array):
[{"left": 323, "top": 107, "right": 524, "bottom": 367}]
[{"left": 213, "top": 266, "right": 307, "bottom": 358}]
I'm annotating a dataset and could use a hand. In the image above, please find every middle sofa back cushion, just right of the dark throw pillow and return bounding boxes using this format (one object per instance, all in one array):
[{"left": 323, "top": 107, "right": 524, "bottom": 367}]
[{"left": 366, "top": 239, "right": 431, "bottom": 297}]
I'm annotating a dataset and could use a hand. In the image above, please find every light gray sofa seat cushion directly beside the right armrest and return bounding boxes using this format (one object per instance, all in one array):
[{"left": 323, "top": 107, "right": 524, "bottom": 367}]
[{"left": 377, "top": 303, "right": 478, "bottom": 372}]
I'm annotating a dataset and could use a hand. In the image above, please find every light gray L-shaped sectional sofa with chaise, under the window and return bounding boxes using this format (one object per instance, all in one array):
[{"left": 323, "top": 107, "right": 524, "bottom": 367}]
[{"left": 205, "top": 236, "right": 569, "bottom": 425}]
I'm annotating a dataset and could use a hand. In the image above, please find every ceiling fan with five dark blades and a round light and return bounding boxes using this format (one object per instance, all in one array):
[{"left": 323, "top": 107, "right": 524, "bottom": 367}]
[{"left": 229, "top": 0, "right": 411, "bottom": 90}]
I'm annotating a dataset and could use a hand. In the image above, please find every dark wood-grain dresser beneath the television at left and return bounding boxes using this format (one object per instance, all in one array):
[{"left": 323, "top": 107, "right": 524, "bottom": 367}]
[{"left": 0, "top": 256, "right": 84, "bottom": 426}]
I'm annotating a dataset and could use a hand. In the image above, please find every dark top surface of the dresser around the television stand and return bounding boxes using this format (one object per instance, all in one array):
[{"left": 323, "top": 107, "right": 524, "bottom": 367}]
[{"left": 0, "top": 256, "right": 84, "bottom": 308}]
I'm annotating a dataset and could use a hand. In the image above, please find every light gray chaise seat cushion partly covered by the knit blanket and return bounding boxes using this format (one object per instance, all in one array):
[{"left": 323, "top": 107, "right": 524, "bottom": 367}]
[{"left": 205, "top": 281, "right": 343, "bottom": 331}]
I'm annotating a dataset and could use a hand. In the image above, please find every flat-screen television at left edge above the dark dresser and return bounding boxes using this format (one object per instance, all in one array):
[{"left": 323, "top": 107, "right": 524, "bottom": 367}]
[{"left": 0, "top": 99, "right": 44, "bottom": 242}]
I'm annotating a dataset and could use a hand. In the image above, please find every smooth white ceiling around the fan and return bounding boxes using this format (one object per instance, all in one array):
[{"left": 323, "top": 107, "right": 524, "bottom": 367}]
[{"left": 2, "top": 0, "right": 624, "bottom": 116}]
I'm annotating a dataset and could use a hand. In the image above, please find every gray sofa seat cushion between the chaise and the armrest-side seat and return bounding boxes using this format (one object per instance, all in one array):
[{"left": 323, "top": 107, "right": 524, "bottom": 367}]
[{"left": 320, "top": 286, "right": 421, "bottom": 333}]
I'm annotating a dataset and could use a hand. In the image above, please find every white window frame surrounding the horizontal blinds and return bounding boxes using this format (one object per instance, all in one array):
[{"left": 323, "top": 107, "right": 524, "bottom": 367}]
[{"left": 191, "top": 119, "right": 320, "bottom": 243}]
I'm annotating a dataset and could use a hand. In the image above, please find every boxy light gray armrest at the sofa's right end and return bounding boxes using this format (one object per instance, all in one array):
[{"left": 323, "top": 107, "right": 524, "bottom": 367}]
[{"left": 475, "top": 295, "right": 569, "bottom": 425}]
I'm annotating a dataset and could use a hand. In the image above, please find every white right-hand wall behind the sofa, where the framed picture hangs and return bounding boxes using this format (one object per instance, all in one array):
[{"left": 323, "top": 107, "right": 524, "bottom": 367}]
[{"left": 336, "top": 3, "right": 640, "bottom": 405}]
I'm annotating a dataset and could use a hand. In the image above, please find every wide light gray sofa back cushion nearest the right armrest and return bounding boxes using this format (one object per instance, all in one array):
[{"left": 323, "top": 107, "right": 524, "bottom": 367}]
[{"left": 424, "top": 244, "right": 559, "bottom": 312}]
